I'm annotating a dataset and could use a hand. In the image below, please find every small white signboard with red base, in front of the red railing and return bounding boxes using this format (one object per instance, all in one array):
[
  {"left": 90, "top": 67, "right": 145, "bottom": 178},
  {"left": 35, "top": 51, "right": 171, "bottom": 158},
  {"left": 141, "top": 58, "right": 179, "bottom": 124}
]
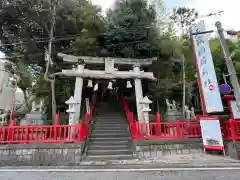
[{"left": 200, "top": 119, "right": 224, "bottom": 150}]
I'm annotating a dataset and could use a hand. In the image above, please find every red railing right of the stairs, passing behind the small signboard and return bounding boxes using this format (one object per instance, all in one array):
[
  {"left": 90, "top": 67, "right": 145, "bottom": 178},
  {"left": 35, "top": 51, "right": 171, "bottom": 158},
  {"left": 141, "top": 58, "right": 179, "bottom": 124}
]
[{"left": 119, "top": 96, "right": 240, "bottom": 142}]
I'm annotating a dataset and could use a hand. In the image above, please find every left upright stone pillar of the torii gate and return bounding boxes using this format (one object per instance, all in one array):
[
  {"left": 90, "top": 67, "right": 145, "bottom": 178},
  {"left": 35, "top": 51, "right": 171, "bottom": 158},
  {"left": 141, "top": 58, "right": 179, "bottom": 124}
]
[{"left": 74, "top": 64, "right": 84, "bottom": 124}]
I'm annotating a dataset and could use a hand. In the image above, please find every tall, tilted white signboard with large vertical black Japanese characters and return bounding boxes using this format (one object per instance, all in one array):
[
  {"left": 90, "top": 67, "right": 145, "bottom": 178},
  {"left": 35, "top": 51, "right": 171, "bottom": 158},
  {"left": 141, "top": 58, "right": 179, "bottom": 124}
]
[{"left": 192, "top": 21, "right": 223, "bottom": 113}]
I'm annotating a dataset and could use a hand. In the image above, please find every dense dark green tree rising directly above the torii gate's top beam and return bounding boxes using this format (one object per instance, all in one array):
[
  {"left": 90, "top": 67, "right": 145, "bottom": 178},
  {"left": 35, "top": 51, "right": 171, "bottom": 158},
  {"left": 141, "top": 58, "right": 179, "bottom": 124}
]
[{"left": 100, "top": 0, "right": 158, "bottom": 58}]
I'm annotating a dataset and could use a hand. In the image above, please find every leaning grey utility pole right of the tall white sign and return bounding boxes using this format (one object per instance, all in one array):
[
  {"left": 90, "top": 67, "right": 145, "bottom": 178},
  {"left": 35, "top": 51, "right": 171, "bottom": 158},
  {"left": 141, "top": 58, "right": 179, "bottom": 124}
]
[{"left": 215, "top": 21, "right": 240, "bottom": 109}]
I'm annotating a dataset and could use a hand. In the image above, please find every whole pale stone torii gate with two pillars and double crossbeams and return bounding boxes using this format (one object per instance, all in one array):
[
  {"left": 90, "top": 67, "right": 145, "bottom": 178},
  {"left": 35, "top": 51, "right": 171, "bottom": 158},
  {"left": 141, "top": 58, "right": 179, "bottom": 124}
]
[{"left": 58, "top": 53, "right": 157, "bottom": 124}]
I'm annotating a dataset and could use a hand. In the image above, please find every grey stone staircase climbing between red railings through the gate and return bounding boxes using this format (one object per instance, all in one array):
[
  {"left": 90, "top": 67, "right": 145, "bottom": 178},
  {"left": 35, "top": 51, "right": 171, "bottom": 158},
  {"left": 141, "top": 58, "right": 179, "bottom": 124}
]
[{"left": 86, "top": 102, "right": 133, "bottom": 160}]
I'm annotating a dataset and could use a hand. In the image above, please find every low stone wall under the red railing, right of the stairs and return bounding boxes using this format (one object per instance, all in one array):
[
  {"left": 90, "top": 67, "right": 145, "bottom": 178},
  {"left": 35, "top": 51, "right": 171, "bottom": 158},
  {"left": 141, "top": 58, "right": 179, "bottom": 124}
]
[{"left": 134, "top": 139, "right": 203, "bottom": 158}]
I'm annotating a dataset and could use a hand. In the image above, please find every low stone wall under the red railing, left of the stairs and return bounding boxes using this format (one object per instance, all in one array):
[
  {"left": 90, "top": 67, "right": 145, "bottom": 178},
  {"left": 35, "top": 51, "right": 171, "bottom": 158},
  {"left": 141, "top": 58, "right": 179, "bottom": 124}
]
[{"left": 0, "top": 142, "right": 84, "bottom": 166}]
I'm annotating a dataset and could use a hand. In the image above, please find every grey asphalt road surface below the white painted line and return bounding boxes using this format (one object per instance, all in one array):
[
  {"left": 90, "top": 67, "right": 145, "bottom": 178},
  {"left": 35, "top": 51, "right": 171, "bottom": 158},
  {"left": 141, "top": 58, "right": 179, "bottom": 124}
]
[{"left": 0, "top": 170, "right": 240, "bottom": 180}]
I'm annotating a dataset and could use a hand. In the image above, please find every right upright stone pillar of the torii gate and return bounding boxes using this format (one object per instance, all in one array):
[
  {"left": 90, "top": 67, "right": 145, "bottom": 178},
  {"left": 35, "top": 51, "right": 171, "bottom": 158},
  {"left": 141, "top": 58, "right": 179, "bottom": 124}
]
[{"left": 133, "top": 65, "right": 144, "bottom": 123}]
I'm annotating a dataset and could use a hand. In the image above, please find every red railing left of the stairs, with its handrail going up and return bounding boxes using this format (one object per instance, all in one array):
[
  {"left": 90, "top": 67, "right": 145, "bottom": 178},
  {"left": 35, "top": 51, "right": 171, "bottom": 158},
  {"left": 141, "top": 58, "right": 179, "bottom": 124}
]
[{"left": 0, "top": 94, "right": 97, "bottom": 144}]
